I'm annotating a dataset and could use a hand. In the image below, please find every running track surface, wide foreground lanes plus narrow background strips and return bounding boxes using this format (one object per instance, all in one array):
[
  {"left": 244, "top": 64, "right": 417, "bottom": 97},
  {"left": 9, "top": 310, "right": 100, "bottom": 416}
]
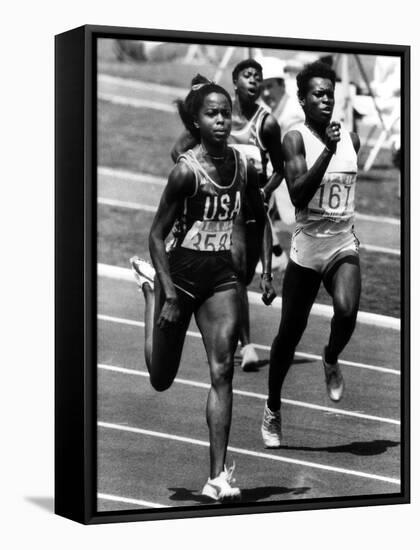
[{"left": 98, "top": 72, "right": 401, "bottom": 511}]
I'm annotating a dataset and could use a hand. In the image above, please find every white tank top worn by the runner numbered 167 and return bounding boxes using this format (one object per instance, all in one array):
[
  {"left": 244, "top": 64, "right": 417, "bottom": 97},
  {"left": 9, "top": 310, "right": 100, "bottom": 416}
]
[{"left": 295, "top": 124, "right": 357, "bottom": 237}]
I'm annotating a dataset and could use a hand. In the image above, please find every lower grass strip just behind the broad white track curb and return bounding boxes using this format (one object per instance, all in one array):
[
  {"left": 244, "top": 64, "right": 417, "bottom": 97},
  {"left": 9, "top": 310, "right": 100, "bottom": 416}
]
[{"left": 98, "top": 205, "right": 401, "bottom": 317}]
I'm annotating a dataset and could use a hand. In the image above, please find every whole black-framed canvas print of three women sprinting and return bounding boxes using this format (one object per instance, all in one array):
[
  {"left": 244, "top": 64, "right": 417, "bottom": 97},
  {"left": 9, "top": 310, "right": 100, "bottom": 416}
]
[{"left": 55, "top": 26, "right": 410, "bottom": 523}]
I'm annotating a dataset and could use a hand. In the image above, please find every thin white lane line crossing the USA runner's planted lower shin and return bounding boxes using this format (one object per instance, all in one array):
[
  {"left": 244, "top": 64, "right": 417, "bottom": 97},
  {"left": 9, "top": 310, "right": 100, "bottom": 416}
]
[{"left": 98, "top": 421, "right": 400, "bottom": 485}]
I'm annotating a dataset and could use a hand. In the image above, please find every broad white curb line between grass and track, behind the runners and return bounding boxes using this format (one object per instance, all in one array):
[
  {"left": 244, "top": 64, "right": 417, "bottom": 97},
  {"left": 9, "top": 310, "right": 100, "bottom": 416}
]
[{"left": 98, "top": 264, "right": 401, "bottom": 331}]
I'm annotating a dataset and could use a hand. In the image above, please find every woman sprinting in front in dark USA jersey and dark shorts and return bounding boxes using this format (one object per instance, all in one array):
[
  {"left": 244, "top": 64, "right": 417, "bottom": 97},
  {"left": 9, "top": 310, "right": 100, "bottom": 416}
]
[{"left": 131, "top": 77, "right": 274, "bottom": 501}]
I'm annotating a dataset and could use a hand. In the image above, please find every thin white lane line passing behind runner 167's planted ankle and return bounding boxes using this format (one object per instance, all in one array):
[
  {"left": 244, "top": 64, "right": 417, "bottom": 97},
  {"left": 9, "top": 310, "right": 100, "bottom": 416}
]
[{"left": 98, "top": 364, "right": 400, "bottom": 426}]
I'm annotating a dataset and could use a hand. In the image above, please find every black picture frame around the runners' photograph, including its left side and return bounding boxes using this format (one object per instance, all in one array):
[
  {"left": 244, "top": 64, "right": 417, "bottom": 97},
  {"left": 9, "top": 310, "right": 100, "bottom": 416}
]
[{"left": 55, "top": 25, "right": 410, "bottom": 524}]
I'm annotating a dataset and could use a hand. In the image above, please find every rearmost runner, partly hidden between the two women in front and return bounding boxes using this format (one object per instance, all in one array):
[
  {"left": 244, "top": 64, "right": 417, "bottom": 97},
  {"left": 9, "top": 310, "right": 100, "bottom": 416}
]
[{"left": 171, "top": 59, "right": 283, "bottom": 371}]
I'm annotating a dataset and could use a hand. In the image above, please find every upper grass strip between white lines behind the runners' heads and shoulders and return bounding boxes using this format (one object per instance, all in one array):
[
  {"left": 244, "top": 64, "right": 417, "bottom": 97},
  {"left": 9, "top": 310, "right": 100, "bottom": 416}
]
[{"left": 98, "top": 101, "right": 400, "bottom": 218}]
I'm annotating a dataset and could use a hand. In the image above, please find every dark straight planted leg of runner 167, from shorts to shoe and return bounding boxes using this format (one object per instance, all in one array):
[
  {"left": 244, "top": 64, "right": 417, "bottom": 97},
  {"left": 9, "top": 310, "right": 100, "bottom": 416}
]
[{"left": 267, "top": 260, "right": 321, "bottom": 411}]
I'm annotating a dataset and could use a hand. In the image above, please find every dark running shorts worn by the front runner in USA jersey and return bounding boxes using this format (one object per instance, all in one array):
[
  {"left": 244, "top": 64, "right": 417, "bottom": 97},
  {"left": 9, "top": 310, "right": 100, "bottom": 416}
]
[{"left": 168, "top": 247, "right": 237, "bottom": 303}]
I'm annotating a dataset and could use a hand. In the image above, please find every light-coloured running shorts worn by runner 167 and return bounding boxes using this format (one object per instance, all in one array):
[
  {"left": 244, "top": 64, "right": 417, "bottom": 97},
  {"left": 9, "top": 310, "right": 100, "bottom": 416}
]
[{"left": 290, "top": 228, "right": 360, "bottom": 275}]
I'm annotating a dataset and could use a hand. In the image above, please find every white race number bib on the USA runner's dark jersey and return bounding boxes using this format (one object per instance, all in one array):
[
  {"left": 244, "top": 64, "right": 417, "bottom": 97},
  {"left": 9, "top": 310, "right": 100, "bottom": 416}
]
[{"left": 182, "top": 220, "right": 233, "bottom": 252}]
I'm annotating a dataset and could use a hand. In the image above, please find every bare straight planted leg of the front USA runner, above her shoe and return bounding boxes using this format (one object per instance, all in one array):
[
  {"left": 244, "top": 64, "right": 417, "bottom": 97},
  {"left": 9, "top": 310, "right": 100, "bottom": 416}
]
[{"left": 196, "top": 289, "right": 239, "bottom": 484}]
